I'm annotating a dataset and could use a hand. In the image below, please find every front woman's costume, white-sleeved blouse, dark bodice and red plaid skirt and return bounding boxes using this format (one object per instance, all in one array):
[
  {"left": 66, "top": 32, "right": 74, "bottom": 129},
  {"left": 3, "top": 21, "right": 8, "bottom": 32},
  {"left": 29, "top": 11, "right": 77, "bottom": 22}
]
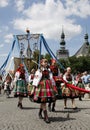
[{"left": 32, "top": 67, "right": 56, "bottom": 103}]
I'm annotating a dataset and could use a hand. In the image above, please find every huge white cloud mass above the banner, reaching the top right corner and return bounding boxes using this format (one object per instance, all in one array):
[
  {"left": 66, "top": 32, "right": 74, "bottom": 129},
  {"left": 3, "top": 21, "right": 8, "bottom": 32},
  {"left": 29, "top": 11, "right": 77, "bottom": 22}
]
[{"left": 13, "top": 0, "right": 90, "bottom": 39}]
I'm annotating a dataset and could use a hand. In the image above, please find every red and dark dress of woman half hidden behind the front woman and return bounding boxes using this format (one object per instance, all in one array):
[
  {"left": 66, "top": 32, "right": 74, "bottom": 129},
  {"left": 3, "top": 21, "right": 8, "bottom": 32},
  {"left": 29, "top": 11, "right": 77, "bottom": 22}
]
[{"left": 50, "top": 65, "right": 63, "bottom": 99}]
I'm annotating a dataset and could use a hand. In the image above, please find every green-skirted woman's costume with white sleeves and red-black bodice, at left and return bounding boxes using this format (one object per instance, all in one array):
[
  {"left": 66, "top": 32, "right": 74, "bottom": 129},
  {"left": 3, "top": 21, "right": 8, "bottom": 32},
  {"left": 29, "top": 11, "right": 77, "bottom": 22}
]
[{"left": 13, "top": 68, "right": 27, "bottom": 97}]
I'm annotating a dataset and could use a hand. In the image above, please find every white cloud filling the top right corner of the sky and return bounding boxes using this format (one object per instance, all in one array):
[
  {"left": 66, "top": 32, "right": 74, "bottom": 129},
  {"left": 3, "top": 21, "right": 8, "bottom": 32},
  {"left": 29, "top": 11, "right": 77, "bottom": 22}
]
[{"left": 65, "top": 0, "right": 90, "bottom": 18}]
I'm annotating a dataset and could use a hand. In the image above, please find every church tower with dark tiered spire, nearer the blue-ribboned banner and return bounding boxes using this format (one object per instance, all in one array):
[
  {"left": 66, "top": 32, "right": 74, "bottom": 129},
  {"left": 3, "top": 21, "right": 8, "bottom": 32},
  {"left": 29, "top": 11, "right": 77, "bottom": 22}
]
[{"left": 56, "top": 29, "right": 69, "bottom": 59}]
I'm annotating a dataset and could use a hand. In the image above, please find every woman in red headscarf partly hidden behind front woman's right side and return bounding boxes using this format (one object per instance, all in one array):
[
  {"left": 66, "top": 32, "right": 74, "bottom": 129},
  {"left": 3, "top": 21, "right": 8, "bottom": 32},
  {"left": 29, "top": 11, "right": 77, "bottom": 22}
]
[{"left": 48, "top": 59, "right": 62, "bottom": 112}]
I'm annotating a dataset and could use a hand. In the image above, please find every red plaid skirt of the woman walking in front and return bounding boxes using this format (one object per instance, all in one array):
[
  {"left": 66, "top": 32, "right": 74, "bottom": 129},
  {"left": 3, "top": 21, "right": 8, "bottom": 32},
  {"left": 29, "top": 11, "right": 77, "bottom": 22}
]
[{"left": 30, "top": 80, "right": 57, "bottom": 103}]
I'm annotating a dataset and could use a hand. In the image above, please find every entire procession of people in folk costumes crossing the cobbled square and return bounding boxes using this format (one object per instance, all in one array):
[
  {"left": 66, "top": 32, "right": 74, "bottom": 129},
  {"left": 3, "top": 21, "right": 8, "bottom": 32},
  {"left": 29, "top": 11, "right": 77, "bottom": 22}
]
[{"left": 0, "top": 58, "right": 90, "bottom": 123}]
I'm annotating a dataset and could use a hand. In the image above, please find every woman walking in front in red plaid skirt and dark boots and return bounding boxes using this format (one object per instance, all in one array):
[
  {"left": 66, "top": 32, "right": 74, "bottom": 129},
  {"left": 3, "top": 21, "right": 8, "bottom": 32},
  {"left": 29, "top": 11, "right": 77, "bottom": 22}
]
[{"left": 32, "top": 59, "right": 56, "bottom": 123}]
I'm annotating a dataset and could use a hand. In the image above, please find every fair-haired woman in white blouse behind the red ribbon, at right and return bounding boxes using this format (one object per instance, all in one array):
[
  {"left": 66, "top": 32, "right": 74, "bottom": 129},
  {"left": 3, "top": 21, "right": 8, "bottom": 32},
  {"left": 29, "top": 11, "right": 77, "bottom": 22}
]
[{"left": 62, "top": 67, "right": 78, "bottom": 109}]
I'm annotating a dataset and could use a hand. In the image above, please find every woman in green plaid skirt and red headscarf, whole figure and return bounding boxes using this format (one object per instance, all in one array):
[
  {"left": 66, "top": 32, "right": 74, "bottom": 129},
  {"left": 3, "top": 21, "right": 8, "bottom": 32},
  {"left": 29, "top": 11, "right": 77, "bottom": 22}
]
[{"left": 13, "top": 64, "right": 27, "bottom": 109}]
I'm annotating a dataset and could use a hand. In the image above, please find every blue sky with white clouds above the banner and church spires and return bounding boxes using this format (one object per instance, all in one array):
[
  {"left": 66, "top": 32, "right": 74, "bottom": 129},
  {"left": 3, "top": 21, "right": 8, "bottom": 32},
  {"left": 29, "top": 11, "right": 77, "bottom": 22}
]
[{"left": 0, "top": 0, "right": 90, "bottom": 69}]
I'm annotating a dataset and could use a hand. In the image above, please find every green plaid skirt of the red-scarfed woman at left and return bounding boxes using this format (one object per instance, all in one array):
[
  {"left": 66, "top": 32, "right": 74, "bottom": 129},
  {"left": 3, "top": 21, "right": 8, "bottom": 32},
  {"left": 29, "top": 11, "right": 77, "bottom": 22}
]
[{"left": 13, "top": 80, "right": 27, "bottom": 97}]
